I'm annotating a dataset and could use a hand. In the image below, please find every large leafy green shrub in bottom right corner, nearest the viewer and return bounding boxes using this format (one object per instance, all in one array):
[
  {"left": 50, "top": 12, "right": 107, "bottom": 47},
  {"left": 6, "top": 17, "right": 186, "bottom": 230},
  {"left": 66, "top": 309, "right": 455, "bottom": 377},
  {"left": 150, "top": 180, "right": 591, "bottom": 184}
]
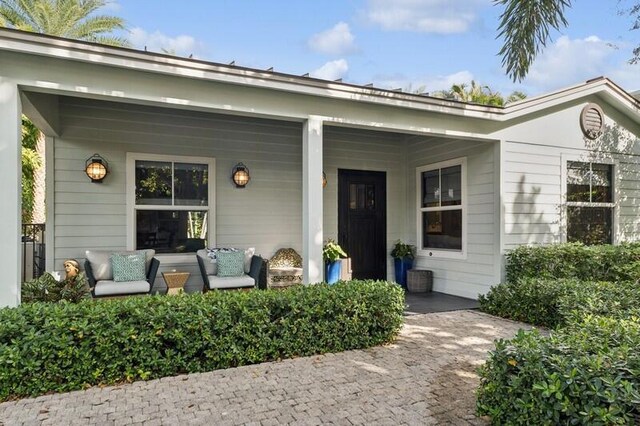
[{"left": 477, "top": 316, "right": 640, "bottom": 425}]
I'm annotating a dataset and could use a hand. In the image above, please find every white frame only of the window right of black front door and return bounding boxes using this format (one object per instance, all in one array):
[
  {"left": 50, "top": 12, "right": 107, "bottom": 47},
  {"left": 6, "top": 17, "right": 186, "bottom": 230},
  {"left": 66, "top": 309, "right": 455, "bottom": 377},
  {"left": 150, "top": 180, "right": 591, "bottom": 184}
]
[{"left": 416, "top": 157, "right": 469, "bottom": 260}]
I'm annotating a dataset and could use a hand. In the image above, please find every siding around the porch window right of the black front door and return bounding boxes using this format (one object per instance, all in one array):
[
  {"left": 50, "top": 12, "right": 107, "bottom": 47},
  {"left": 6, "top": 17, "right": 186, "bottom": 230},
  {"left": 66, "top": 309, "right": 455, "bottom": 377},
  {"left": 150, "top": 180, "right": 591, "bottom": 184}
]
[{"left": 406, "top": 136, "right": 500, "bottom": 298}]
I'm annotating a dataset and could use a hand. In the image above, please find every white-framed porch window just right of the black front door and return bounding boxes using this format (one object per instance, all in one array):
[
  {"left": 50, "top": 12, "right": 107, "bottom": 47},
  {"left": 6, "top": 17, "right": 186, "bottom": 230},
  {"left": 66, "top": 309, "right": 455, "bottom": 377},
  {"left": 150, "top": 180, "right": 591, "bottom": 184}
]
[{"left": 417, "top": 158, "right": 467, "bottom": 257}]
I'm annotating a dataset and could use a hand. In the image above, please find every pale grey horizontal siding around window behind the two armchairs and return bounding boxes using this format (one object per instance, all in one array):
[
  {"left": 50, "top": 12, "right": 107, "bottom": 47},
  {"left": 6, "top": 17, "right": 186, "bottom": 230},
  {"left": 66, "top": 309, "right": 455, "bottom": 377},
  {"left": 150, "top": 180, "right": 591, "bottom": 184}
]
[{"left": 54, "top": 98, "right": 302, "bottom": 290}]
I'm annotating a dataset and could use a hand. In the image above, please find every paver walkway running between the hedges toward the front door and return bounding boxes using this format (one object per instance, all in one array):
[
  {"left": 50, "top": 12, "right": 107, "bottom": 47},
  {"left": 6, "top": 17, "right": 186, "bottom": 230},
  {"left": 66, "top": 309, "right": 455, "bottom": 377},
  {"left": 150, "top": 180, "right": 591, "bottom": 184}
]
[{"left": 0, "top": 311, "right": 526, "bottom": 425}]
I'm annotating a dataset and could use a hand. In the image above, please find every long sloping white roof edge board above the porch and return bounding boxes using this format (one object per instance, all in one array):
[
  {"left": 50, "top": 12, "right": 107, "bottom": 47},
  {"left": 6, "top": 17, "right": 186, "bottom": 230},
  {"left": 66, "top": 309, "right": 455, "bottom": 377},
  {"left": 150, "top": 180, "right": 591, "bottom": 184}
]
[{"left": 0, "top": 30, "right": 503, "bottom": 120}]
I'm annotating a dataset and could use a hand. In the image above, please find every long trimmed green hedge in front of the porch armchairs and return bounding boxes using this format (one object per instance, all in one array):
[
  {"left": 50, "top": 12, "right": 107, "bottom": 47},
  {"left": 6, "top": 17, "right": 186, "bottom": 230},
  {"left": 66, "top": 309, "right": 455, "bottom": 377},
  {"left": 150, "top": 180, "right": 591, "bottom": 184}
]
[{"left": 0, "top": 281, "right": 404, "bottom": 400}]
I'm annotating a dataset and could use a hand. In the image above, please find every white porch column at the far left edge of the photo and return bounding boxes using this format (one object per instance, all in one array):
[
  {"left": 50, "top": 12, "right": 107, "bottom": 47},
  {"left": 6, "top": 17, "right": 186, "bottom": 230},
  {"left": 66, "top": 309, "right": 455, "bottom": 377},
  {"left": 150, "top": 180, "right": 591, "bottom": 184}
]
[{"left": 0, "top": 77, "right": 22, "bottom": 307}]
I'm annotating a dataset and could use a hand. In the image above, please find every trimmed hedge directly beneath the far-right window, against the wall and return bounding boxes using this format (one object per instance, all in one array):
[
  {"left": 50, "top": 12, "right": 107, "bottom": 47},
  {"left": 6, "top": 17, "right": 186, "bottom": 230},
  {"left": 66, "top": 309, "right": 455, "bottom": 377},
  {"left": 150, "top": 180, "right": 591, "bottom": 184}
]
[{"left": 506, "top": 243, "right": 640, "bottom": 282}]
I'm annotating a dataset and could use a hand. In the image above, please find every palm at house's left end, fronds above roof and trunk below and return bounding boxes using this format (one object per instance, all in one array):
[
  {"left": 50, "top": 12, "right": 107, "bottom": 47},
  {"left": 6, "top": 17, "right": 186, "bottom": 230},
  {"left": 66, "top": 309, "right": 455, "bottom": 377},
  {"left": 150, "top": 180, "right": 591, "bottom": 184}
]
[{"left": 0, "top": 0, "right": 129, "bottom": 223}]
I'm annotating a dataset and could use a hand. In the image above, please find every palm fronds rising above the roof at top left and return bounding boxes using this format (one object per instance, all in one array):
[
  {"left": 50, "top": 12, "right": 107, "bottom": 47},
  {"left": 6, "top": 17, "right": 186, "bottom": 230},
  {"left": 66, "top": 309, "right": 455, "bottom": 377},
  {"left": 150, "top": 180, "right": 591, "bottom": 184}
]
[{"left": 0, "top": 0, "right": 129, "bottom": 46}]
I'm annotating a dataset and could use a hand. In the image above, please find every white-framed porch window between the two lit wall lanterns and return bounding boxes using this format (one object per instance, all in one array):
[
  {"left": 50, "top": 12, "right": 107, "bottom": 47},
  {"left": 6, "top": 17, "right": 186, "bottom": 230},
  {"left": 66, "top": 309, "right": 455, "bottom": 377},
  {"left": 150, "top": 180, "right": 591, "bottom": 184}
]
[{"left": 127, "top": 153, "right": 215, "bottom": 253}]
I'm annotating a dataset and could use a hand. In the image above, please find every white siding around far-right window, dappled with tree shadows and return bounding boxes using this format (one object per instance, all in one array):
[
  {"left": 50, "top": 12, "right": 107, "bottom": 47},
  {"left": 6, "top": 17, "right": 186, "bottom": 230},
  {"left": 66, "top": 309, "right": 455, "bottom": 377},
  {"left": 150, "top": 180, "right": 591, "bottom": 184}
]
[{"left": 503, "top": 132, "right": 640, "bottom": 249}]
